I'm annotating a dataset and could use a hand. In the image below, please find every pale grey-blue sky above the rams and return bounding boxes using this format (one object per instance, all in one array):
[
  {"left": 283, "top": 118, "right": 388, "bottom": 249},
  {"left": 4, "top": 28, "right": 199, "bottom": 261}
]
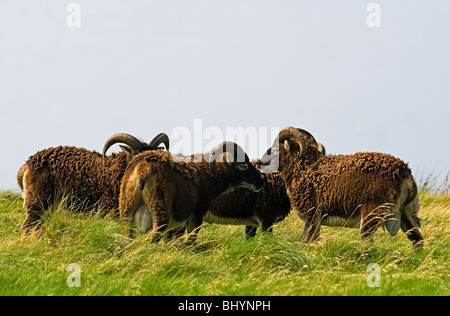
[{"left": 0, "top": 0, "right": 450, "bottom": 190}]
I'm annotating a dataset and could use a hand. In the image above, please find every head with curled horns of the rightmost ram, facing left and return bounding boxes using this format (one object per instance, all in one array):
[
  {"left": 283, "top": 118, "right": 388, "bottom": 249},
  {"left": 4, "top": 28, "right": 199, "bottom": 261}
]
[{"left": 259, "top": 127, "right": 326, "bottom": 173}]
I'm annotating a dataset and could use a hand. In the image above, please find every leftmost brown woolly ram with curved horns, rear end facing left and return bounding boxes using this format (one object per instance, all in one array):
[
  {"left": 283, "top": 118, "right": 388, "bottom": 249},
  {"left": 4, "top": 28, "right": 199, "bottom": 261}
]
[{"left": 17, "top": 133, "right": 169, "bottom": 237}]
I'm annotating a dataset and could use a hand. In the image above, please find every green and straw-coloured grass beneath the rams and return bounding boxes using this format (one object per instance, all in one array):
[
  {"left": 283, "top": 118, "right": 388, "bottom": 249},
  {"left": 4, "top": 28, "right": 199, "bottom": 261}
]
[{"left": 0, "top": 193, "right": 450, "bottom": 296}]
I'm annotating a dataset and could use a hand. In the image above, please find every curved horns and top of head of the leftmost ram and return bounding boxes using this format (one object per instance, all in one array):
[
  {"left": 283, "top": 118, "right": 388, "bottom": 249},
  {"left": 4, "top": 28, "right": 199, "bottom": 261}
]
[{"left": 103, "top": 133, "right": 169, "bottom": 160}]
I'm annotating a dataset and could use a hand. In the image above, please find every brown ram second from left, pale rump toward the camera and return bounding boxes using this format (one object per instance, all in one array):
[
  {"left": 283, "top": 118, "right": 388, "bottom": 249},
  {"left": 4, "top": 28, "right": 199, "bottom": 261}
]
[{"left": 119, "top": 142, "right": 263, "bottom": 242}]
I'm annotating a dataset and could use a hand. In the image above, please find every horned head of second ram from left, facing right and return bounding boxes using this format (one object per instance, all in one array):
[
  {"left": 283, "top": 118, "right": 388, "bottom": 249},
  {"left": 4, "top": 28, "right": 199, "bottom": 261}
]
[{"left": 209, "top": 142, "right": 264, "bottom": 192}]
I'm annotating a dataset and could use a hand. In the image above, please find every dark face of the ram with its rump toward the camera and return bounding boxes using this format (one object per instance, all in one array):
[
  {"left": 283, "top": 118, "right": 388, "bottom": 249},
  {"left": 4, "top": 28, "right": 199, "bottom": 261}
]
[{"left": 230, "top": 159, "right": 264, "bottom": 192}]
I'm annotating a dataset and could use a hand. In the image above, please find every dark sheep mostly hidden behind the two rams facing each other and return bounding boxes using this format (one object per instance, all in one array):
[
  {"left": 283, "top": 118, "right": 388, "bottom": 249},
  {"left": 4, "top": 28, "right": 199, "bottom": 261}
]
[{"left": 204, "top": 139, "right": 326, "bottom": 239}]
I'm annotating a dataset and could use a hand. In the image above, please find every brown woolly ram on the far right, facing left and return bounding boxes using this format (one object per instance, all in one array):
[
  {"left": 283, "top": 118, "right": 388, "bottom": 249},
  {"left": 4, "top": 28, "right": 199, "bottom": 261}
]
[{"left": 260, "top": 127, "right": 423, "bottom": 251}]
